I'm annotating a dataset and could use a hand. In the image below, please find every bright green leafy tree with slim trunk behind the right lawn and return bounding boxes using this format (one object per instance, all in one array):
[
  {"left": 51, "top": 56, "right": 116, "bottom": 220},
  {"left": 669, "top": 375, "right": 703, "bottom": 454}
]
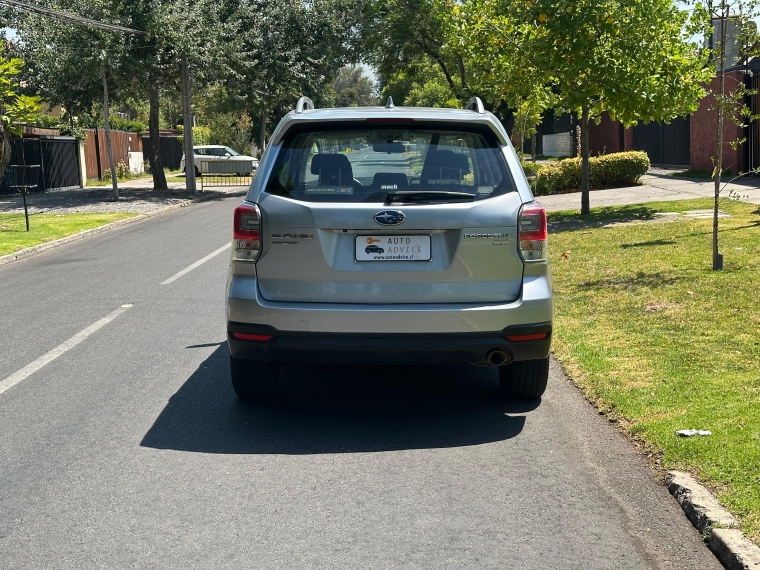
[{"left": 457, "top": 0, "right": 709, "bottom": 214}]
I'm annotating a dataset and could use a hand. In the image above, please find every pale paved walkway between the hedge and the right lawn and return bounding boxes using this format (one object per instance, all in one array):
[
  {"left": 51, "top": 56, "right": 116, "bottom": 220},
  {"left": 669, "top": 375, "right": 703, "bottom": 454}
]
[{"left": 536, "top": 168, "right": 760, "bottom": 212}]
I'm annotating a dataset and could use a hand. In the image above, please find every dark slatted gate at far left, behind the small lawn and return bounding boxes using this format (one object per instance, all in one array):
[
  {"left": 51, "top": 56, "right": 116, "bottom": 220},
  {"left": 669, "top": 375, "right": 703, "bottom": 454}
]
[{"left": 0, "top": 137, "right": 81, "bottom": 195}]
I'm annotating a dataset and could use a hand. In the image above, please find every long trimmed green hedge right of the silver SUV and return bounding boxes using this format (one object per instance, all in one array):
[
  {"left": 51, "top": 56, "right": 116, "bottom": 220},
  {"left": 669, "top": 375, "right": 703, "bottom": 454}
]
[{"left": 530, "top": 151, "right": 649, "bottom": 196}]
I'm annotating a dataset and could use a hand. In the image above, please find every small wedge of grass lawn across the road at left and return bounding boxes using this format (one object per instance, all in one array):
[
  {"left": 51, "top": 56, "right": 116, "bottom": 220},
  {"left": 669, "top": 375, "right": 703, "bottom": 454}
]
[{"left": 0, "top": 213, "right": 137, "bottom": 255}]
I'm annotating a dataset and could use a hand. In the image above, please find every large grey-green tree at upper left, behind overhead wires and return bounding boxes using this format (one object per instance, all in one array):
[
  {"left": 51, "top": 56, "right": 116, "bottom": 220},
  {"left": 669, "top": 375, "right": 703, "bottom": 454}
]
[{"left": 14, "top": 0, "right": 236, "bottom": 193}]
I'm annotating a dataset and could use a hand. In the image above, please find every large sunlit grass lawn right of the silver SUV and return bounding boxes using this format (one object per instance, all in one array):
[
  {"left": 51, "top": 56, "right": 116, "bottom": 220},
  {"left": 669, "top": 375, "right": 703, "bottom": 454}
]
[{"left": 549, "top": 199, "right": 760, "bottom": 543}]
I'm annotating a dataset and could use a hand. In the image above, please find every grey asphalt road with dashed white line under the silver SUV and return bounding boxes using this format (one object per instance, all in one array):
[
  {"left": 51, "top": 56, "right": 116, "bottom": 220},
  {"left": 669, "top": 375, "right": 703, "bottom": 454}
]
[{"left": 0, "top": 194, "right": 720, "bottom": 570}]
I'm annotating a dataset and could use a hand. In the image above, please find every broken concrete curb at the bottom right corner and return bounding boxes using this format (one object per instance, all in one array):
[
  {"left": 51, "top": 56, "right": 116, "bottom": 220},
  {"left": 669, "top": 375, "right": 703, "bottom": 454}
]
[{"left": 666, "top": 471, "right": 760, "bottom": 570}]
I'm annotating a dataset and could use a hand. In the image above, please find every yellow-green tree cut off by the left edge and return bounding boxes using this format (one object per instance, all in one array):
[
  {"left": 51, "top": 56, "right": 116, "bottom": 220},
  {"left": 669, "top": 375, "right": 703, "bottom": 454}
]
[{"left": 0, "top": 49, "right": 40, "bottom": 179}]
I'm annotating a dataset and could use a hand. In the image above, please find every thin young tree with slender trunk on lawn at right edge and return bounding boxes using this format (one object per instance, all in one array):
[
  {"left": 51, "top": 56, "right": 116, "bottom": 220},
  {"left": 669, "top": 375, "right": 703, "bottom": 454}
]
[{"left": 705, "top": 0, "right": 760, "bottom": 271}]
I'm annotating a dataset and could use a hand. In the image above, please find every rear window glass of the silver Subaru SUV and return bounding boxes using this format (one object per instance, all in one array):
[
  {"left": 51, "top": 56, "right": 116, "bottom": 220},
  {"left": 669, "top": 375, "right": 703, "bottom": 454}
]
[{"left": 265, "top": 125, "right": 515, "bottom": 203}]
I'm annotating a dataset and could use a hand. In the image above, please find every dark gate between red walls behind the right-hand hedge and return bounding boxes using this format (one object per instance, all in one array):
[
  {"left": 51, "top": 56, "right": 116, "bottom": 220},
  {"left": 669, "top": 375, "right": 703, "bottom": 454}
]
[{"left": 633, "top": 117, "right": 691, "bottom": 168}]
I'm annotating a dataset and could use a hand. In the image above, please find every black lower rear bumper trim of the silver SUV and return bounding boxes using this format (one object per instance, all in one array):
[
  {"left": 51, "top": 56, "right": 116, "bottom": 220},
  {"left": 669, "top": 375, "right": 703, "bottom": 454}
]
[{"left": 227, "top": 322, "right": 552, "bottom": 364}]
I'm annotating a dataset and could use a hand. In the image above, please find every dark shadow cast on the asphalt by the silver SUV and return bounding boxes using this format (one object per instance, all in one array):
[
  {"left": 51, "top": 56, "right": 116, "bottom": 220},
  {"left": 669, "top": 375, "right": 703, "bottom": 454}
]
[{"left": 141, "top": 343, "right": 539, "bottom": 455}]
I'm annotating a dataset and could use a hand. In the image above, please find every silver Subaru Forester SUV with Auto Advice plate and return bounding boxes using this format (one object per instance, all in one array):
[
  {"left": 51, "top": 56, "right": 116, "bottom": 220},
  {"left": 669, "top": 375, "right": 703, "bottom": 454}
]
[{"left": 227, "top": 97, "right": 553, "bottom": 400}]
